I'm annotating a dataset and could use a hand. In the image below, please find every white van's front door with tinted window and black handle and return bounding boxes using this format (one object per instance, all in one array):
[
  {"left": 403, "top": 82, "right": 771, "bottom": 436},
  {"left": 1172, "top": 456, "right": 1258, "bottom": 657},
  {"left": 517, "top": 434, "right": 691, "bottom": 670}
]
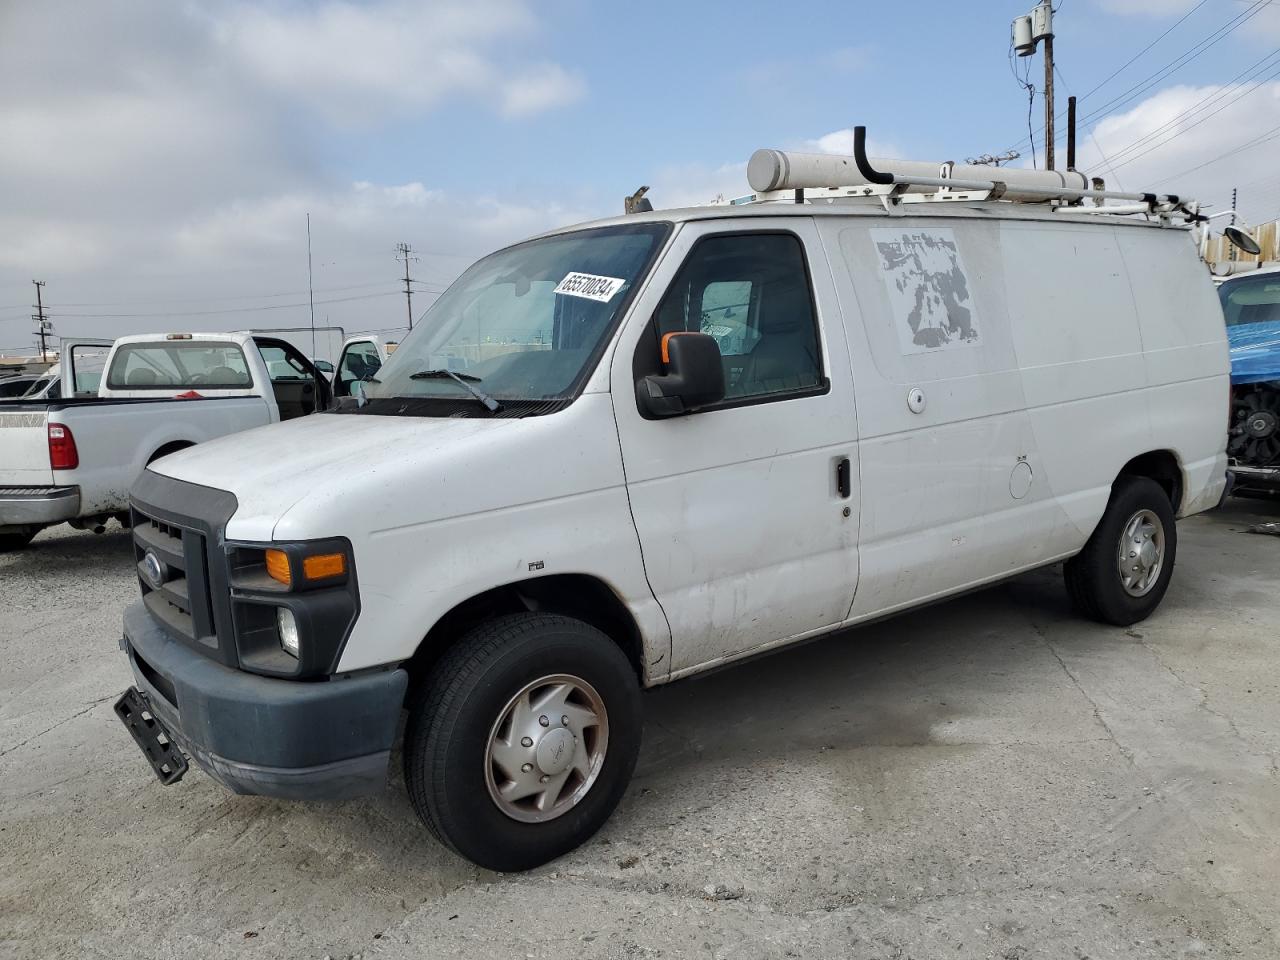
[{"left": 611, "top": 218, "right": 859, "bottom": 675}]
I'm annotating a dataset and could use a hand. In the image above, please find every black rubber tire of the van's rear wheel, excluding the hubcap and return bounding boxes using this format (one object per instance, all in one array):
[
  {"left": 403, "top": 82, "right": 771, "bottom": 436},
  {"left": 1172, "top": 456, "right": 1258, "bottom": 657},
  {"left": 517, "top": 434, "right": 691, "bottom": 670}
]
[{"left": 1064, "top": 476, "right": 1178, "bottom": 627}]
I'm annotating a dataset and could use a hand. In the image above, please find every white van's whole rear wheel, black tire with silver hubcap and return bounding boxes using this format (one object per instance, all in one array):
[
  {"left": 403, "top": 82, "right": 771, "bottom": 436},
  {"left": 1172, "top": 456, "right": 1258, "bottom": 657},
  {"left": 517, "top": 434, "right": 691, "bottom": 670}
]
[{"left": 1065, "top": 476, "right": 1178, "bottom": 627}]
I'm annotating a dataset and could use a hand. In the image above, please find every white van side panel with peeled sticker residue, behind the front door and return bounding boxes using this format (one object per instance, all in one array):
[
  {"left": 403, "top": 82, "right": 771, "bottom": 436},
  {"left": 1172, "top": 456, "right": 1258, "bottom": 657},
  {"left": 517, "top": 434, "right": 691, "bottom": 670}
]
[{"left": 819, "top": 211, "right": 1079, "bottom": 620}]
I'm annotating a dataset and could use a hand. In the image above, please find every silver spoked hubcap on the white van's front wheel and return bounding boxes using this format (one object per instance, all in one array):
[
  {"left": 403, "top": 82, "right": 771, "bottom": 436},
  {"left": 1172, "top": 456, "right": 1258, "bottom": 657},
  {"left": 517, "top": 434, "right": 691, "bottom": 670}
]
[{"left": 484, "top": 673, "right": 609, "bottom": 823}]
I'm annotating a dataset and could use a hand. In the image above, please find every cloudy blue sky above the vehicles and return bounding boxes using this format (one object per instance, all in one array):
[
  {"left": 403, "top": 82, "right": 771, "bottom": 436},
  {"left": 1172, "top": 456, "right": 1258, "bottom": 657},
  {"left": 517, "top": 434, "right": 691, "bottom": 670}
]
[{"left": 0, "top": 0, "right": 1280, "bottom": 351}]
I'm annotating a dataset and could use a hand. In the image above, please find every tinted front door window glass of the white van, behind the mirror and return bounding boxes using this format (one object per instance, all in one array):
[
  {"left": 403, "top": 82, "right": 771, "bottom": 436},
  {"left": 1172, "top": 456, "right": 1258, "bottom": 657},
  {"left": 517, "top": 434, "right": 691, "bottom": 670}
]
[{"left": 654, "top": 233, "right": 826, "bottom": 403}]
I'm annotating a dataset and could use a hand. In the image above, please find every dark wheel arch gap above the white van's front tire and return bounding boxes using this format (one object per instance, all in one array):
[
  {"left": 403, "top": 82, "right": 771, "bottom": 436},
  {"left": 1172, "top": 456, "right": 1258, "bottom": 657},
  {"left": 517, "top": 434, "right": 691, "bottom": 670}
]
[{"left": 404, "top": 573, "right": 646, "bottom": 687}]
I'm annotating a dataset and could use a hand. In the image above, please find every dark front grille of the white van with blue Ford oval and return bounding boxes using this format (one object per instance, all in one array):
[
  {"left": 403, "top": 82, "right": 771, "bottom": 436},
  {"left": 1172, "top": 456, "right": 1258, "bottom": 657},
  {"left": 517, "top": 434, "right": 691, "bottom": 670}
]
[{"left": 133, "top": 506, "right": 232, "bottom": 662}]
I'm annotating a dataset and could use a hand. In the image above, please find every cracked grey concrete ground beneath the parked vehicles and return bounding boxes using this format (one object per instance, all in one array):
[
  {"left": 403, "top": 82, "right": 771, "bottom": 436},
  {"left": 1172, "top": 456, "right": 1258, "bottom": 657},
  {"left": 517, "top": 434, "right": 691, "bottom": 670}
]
[{"left": 0, "top": 500, "right": 1280, "bottom": 960}]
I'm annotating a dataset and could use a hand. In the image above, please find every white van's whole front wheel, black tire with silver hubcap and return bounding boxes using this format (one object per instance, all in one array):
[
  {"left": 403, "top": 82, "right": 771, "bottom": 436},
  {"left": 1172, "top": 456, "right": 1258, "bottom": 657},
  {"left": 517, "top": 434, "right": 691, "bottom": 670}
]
[{"left": 404, "top": 613, "right": 641, "bottom": 870}]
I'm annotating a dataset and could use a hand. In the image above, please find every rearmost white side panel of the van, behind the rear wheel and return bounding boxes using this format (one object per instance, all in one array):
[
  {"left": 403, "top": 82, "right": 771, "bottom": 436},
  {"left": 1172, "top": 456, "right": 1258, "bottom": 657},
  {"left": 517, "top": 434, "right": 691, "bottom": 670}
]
[{"left": 1116, "top": 229, "right": 1231, "bottom": 516}]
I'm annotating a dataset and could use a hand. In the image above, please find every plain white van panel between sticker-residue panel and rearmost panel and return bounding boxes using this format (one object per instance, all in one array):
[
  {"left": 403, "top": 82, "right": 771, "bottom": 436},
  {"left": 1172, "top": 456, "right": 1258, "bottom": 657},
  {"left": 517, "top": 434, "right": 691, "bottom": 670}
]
[{"left": 1001, "top": 221, "right": 1167, "bottom": 550}]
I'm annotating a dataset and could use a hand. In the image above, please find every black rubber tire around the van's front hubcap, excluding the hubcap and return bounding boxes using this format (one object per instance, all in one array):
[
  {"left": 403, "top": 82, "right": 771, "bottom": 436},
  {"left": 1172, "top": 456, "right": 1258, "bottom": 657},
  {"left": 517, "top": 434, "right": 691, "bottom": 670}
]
[{"left": 404, "top": 613, "right": 641, "bottom": 870}]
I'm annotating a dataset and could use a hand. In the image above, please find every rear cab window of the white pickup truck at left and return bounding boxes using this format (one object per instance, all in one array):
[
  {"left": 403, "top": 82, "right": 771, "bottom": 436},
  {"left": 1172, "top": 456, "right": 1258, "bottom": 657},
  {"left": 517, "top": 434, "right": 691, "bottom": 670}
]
[{"left": 106, "top": 340, "right": 253, "bottom": 390}]
